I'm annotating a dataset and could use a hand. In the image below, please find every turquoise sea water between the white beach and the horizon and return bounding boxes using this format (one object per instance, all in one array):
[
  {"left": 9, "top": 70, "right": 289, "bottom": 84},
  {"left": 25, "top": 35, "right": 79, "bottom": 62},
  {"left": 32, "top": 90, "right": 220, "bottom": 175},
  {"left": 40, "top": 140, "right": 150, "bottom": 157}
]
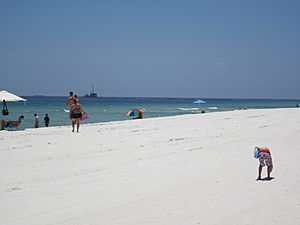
[{"left": 1, "top": 96, "right": 300, "bottom": 128}]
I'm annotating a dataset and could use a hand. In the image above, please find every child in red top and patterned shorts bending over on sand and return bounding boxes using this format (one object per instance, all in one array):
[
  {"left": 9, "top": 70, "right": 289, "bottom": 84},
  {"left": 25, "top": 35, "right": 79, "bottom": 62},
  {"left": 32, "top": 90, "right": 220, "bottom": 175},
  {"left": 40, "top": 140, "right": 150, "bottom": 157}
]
[{"left": 255, "top": 147, "right": 273, "bottom": 180}]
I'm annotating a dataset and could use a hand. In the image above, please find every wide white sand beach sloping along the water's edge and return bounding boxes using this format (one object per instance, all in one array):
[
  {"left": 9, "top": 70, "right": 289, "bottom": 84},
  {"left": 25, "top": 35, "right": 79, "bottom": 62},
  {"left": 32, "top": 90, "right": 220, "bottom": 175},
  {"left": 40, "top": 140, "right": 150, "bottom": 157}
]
[{"left": 0, "top": 108, "right": 300, "bottom": 225}]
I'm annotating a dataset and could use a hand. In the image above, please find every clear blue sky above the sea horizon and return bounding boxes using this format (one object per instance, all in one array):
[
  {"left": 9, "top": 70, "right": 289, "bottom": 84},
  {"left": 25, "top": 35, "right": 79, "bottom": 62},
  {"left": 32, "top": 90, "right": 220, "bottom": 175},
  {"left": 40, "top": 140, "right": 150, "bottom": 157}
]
[{"left": 0, "top": 0, "right": 300, "bottom": 99}]
